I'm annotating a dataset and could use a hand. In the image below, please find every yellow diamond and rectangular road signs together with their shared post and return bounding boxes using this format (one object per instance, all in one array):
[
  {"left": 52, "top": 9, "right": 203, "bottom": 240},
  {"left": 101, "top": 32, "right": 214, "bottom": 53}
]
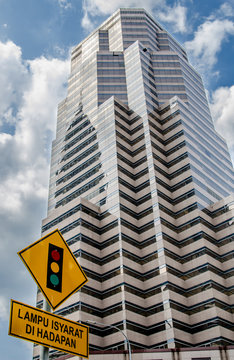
[{"left": 9, "top": 230, "right": 89, "bottom": 360}]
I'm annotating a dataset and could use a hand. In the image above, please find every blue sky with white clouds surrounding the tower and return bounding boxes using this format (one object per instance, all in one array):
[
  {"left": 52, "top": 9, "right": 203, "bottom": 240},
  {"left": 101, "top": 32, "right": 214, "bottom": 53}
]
[{"left": 0, "top": 0, "right": 234, "bottom": 360}]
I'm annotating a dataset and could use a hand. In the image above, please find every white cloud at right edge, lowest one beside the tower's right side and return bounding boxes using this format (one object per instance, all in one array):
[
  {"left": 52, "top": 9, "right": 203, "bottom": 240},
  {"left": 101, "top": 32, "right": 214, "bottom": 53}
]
[{"left": 210, "top": 85, "right": 234, "bottom": 162}]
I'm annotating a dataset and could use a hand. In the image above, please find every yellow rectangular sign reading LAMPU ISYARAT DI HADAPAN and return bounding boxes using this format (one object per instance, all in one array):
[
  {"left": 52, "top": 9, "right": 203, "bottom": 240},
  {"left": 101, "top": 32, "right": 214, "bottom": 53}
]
[{"left": 9, "top": 300, "right": 89, "bottom": 358}]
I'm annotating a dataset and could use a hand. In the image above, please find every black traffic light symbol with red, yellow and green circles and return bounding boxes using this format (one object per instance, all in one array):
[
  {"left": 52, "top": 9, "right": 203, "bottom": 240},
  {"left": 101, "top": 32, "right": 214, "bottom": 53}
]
[{"left": 46, "top": 243, "right": 63, "bottom": 292}]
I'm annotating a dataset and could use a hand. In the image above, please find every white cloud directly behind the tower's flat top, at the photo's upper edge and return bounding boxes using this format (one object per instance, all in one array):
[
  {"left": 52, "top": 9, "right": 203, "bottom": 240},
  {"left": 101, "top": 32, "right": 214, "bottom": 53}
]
[{"left": 82, "top": 0, "right": 187, "bottom": 32}]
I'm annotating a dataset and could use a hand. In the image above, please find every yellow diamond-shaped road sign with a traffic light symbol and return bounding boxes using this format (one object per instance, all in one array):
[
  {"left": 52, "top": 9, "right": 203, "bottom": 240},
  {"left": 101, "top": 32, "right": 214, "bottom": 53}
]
[{"left": 18, "top": 230, "right": 88, "bottom": 309}]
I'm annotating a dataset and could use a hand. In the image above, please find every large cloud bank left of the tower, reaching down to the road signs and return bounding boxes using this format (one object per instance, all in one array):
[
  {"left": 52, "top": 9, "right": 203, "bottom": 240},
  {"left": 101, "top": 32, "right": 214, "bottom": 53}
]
[{"left": 0, "top": 41, "right": 69, "bottom": 324}]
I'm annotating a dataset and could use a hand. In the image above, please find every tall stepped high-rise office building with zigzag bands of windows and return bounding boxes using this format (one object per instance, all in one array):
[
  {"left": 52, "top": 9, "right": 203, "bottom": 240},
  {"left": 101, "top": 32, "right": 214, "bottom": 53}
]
[{"left": 34, "top": 9, "right": 234, "bottom": 359}]
